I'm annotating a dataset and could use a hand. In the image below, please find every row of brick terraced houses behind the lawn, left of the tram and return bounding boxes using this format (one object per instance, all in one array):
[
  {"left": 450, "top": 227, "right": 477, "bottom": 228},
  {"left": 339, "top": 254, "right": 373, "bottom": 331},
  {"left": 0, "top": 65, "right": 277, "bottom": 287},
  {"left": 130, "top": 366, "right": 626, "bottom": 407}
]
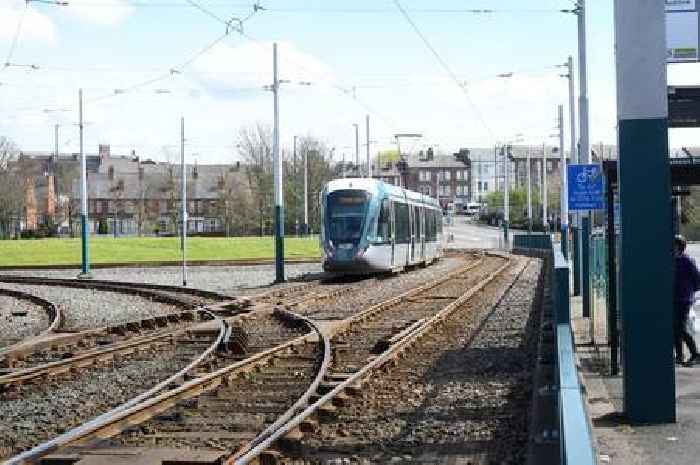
[{"left": 20, "top": 145, "right": 247, "bottom": 235}]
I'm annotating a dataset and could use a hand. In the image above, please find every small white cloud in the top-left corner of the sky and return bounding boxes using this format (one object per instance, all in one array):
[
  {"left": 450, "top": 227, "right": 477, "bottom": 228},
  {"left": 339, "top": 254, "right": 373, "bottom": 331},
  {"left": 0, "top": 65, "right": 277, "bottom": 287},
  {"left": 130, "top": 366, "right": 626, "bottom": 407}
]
[{"left": 0, "top": 0, "right": 56, "bottom": 45}]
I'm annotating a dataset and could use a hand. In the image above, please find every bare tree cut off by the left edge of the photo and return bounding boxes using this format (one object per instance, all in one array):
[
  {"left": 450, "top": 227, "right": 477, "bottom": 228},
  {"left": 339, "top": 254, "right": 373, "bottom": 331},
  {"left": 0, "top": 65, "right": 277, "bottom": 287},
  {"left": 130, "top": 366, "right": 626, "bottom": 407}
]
[{"left": 0, "top": 136, "right": 25, "bottom": 239}]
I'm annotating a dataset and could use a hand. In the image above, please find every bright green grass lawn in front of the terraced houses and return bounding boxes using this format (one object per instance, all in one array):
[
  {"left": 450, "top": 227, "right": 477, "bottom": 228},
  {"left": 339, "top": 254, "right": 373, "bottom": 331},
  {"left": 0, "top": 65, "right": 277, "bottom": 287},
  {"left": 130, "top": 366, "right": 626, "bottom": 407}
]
[{"left": 0, "top": 236, "right": 321, "bottom": 267}]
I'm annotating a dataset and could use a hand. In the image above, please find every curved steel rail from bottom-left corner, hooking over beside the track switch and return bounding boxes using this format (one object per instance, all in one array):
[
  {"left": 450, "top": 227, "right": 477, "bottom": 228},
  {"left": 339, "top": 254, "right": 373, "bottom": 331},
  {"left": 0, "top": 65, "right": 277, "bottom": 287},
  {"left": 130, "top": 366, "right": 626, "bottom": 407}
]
[{"left": 3, "top": 313, "right": 228, "bottom": 465}]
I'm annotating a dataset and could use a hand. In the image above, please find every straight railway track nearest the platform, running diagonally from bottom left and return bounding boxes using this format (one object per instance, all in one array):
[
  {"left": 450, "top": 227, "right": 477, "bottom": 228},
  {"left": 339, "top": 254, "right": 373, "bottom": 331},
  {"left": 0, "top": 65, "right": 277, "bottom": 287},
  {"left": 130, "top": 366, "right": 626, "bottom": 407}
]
[{"left": 2, "top": 250, "right": 510, "bottom": 464}]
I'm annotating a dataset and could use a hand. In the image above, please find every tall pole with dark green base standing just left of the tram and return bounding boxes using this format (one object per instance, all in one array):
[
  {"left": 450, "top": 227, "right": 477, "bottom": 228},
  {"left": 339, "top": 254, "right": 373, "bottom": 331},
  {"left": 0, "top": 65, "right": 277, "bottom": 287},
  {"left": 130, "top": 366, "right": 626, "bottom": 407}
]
[{"left": 272, "top": 42, "right": 285, "bottom": 283}]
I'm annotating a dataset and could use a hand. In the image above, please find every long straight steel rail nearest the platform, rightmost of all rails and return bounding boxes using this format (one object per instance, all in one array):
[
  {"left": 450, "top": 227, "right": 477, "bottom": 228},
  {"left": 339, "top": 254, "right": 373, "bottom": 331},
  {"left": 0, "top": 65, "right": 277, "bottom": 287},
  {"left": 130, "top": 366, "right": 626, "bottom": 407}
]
[{"left": 233, "top": 254, "right": 511, "bottom": 465}]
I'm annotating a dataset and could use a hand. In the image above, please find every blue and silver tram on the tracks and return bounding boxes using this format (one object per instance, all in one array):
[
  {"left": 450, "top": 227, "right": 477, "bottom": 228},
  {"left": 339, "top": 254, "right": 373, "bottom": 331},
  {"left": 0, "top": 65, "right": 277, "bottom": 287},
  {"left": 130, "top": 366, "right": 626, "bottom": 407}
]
[{"left": 320, "top": 178, "right": 442, "bottom": 274}]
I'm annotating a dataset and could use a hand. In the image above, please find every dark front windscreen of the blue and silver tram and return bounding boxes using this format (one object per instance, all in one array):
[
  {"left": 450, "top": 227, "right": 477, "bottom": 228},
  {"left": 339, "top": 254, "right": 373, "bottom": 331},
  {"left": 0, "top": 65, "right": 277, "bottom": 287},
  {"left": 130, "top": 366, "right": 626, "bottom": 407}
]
[{"left": 325, "top": 191, "right": 369, "bottom": 245}]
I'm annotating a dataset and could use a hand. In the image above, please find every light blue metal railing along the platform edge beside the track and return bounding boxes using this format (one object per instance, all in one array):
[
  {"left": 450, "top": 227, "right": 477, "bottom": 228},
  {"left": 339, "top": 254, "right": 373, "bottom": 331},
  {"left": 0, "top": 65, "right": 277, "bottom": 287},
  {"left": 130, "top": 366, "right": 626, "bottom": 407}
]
[{"left": 552, "top": 246, "right": 597, "bottom": 465}]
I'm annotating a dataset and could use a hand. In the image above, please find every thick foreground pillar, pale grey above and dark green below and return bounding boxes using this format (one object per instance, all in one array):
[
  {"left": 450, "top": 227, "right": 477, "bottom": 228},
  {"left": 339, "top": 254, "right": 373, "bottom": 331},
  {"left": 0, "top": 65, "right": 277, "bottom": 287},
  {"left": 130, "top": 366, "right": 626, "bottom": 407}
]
[{"left": 615, "top": 0, "right": 676, "bottom": 423}]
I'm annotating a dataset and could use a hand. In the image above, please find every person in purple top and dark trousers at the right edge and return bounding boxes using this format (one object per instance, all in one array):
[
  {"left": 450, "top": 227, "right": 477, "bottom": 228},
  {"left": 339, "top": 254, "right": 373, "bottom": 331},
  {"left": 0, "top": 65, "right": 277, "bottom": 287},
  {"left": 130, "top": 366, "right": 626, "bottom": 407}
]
[{"left": 673, "top": 235, "right": 700, "bottom": 365}]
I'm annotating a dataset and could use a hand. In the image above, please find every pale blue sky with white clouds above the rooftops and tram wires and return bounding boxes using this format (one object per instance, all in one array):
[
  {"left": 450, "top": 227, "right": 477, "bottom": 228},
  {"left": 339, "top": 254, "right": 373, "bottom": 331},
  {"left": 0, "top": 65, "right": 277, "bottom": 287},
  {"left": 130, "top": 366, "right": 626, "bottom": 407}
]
[{"left": 0, "top": 0, "right": 700, "bottom": 163}]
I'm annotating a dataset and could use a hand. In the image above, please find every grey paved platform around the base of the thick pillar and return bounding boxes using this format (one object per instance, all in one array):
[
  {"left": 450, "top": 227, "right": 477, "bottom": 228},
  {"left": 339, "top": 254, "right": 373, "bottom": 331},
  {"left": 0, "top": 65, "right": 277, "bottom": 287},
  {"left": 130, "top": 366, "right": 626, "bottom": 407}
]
[{"left": 571, "top": 297, "right": 700, "bottom": 465}]
